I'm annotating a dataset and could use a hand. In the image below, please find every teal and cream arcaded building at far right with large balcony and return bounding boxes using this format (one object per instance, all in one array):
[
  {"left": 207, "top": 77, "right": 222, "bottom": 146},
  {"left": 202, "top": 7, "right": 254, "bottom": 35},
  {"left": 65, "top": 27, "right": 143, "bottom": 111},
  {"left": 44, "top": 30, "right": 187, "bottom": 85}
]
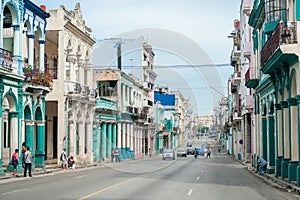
[{"left": 249, "top": 0, "right": 300, "bottom": 186}]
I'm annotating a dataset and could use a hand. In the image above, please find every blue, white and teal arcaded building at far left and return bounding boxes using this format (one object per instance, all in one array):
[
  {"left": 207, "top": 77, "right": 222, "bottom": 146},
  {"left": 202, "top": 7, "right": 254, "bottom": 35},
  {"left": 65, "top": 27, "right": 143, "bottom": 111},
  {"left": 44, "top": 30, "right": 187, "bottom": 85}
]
[{"left": 0, "top": 0, "right": 51, "bottom": 175}]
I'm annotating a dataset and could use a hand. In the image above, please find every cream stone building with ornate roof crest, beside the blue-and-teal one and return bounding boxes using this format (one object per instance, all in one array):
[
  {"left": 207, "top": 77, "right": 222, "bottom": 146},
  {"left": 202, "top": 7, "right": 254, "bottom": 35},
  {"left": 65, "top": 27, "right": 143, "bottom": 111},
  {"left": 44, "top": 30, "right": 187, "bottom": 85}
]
[{"left": 45, "top": 3, "right": 96, "bottom": 164}]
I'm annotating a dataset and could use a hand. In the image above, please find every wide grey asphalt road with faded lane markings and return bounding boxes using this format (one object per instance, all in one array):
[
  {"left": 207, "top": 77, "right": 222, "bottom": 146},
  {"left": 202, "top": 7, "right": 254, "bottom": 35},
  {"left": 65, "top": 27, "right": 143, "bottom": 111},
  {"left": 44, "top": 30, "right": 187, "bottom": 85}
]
[{"left": 0, "top": 138, "right": 299, "bottom": 200}]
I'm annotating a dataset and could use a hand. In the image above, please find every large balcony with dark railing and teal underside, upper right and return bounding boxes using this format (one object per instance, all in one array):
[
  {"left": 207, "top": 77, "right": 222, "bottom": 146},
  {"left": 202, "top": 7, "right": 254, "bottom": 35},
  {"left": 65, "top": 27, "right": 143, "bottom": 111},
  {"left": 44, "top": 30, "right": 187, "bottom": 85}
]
[{"left": 261, "top": 22, "right": 298, "bottom": 75}]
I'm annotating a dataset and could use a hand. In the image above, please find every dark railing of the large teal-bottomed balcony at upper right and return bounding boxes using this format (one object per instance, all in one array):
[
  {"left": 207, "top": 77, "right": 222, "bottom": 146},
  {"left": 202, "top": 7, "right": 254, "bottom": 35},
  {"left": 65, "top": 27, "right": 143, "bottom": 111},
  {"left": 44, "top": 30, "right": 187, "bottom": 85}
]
[{"left": 261, "top": 22, "right": 297, "bottom": 66}]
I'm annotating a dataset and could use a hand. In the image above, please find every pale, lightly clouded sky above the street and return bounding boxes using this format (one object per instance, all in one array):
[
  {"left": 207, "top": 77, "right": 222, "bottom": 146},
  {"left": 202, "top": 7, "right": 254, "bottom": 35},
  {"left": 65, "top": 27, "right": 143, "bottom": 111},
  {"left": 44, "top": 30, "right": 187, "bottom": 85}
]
[{"left": 32, "top": 0, "right": 241, "bottom": 115}]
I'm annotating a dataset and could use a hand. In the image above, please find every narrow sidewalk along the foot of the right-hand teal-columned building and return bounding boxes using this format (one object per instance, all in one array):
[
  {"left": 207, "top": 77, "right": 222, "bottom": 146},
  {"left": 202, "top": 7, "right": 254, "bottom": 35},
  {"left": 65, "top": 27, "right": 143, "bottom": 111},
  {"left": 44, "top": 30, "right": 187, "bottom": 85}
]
[{"left": 236, "top": 155, "right": 300, "bottom": 195}]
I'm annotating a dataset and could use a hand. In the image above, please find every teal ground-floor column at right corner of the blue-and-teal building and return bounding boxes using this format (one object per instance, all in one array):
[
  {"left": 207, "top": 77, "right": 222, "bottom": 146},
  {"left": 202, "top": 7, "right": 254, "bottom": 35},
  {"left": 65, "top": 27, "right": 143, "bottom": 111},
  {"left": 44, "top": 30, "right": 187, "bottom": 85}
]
[{"left": 35, "top": 121, "right": 45, "bottom": 168}]
